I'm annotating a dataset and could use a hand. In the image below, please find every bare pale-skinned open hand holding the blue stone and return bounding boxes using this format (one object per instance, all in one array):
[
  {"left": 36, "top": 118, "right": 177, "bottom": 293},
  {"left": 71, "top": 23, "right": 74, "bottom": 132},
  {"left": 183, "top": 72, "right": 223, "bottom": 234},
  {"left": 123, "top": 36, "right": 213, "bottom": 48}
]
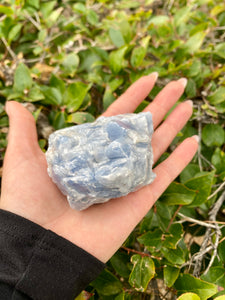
[{"left": 0, "top": 73, "right": 198, "bottom": 262}]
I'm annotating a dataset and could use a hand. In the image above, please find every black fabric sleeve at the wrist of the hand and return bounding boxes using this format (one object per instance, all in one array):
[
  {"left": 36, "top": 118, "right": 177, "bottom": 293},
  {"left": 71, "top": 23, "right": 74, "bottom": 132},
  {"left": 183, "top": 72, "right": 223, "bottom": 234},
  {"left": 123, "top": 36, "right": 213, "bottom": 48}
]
[{"left": 0, "top": 209, "right": 105, "bottom": 300}]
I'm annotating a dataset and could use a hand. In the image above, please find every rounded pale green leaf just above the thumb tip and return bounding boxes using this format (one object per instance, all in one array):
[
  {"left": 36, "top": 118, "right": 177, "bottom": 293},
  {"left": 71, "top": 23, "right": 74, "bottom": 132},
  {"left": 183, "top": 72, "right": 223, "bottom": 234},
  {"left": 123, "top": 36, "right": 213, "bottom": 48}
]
[{"left": 13, "top": 63, "right": 33, "bottom": 93}]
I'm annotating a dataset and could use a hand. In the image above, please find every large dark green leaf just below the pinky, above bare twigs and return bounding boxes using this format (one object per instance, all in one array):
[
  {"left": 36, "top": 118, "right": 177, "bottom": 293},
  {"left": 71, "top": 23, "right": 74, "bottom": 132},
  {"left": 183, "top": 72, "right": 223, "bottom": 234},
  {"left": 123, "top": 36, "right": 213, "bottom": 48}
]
[{"left": 185, "top": 171, "right": 215, "bottom": 207}]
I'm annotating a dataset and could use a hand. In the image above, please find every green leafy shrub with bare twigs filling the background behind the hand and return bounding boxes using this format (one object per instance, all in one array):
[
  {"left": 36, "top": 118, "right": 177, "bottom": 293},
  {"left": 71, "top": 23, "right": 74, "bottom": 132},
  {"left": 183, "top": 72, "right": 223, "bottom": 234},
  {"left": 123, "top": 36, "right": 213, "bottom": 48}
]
[{"left": 0, "top": 0, "right": 225, "bottom": 300}]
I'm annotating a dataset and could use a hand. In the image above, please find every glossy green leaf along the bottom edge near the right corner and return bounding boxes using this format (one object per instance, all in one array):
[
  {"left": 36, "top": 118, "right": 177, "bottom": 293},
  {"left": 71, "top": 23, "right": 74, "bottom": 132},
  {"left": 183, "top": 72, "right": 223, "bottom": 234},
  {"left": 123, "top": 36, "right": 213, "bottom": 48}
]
[{"left": 174, "top": 274, "right": 217, "bottom": 300}]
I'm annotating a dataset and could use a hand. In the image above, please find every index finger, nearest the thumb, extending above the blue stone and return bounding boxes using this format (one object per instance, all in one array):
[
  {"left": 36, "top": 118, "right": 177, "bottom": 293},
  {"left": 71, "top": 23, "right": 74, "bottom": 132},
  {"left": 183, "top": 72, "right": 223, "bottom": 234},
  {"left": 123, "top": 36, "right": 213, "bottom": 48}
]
[{"left": 103, "top": 72, "right": 158, "bottom": 117}]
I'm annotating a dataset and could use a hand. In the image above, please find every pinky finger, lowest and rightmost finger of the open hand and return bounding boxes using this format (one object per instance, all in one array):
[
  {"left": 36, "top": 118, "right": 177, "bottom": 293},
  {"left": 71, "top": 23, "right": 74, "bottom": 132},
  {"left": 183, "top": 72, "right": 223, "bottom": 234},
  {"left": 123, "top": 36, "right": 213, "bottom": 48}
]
[{"left": 149, "top": 136, "right": 198, "bottom": 201}]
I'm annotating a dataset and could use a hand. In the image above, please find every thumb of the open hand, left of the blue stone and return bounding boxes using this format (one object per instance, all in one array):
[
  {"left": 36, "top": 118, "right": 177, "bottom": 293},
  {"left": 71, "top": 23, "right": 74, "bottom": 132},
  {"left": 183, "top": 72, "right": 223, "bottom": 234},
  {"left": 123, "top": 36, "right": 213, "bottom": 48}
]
[{"left": 5, "top": 101, "right": 40, "bottom": 152}]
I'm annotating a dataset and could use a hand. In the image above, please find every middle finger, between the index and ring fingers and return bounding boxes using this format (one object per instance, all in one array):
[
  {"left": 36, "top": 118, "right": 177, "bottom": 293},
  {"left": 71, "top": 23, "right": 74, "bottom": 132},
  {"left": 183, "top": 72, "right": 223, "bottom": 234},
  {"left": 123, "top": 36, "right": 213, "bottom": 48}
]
[{"left": 144, "top": 78, "right": 187, "bottom": 128}]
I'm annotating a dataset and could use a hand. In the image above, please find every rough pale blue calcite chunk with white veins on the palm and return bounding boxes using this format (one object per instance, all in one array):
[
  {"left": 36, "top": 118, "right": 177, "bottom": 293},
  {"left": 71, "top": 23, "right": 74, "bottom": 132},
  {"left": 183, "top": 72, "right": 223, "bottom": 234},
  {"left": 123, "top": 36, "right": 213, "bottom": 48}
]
[{"left": 46, "top": 112, "right": 155, "bottom": 210}]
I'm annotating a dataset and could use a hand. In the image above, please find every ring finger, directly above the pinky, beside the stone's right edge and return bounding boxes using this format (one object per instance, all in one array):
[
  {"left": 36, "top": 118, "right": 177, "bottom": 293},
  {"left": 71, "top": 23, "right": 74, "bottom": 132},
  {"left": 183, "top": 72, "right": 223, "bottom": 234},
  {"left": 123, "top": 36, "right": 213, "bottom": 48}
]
[{"left": 152, "top": 100, "right": 193, "bottom": 162}]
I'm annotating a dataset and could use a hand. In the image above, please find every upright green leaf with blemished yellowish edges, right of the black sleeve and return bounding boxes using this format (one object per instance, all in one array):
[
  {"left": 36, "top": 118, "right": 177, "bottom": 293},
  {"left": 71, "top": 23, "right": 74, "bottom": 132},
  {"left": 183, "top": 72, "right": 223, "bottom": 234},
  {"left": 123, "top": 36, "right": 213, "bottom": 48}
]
[{"left": 129, "top": 254, "right": 155, "bottom": 292}]
